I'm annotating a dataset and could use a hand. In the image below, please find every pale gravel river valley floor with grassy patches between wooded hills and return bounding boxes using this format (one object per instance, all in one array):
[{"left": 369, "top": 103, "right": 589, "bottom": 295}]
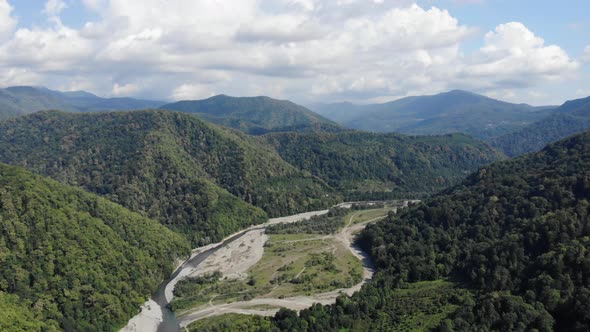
[{"left": 123, "top": 201, "right": 407, "bottom": 331}]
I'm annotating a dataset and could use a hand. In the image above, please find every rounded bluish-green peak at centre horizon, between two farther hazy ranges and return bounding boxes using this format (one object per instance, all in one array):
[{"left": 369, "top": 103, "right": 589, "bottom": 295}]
[{"left": 160, "top": 95, "right": 342, "bottom": 135}]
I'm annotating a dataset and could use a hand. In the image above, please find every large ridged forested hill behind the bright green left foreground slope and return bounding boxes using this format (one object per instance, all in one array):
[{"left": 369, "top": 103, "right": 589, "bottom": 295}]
[{"left": 0, "top": 111, "right": 341, "bottom": 244}]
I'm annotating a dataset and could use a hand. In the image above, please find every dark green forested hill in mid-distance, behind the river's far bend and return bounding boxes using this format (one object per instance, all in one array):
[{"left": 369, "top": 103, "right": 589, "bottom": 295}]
[{"left": 261, "top": 131, "right": 502, "bottom": 200}]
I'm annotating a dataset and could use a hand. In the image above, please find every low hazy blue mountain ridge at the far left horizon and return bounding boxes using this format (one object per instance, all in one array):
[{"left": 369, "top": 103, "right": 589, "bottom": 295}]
[{"left": 0, "top": 86, "right": 164, "bottom": 119}]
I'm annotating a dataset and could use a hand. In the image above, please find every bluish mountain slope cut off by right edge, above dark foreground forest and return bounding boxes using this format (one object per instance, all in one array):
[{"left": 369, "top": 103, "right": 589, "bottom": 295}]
[{"left": 490, "top": 97, "right": 590, "bottom": 157}]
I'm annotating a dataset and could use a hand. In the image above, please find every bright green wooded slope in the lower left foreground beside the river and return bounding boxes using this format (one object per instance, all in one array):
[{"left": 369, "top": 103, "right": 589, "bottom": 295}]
[{"left": 0, "top": 164, "right": 190, "bottom": 331}]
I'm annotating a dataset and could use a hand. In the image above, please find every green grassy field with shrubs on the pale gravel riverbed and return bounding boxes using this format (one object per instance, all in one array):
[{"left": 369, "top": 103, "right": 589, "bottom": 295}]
[{"left": 172, "top": 234, "right": 363, "bottom": 311}]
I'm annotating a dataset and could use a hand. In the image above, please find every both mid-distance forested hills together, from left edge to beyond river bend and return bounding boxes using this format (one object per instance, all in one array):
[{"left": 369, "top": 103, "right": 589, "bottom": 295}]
[{"left": 0, "top": 111, "right": 502, "bottom": 245}]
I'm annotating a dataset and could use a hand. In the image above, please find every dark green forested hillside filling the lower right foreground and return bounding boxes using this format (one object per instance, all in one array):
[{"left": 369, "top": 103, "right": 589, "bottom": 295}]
[{"left": 266, "top": 128, "right": 590, "bottom": 331}]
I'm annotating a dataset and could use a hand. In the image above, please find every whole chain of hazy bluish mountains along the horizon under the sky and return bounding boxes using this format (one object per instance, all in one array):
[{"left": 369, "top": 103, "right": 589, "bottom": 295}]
[{"left": 0, "top": 86, "right": 590, "bottom": 160}]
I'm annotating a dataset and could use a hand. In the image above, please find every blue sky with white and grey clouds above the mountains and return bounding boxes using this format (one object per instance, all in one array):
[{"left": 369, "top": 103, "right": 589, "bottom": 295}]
[{"left": 0, "top": 0, "right": 590, "bottom": 105}]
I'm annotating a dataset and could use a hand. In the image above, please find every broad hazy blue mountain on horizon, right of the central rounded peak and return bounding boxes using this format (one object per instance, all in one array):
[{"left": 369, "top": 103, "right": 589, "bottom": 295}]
[{"left": 314, "top": 90, "right": 551, "bottom": 139}]
